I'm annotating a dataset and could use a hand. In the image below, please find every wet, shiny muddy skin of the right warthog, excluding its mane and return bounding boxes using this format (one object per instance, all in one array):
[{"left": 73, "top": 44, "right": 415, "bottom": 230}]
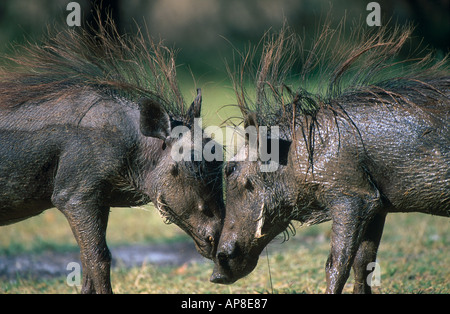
[{"left": 211, "top": 23, "right": 450, "bottom": 293}]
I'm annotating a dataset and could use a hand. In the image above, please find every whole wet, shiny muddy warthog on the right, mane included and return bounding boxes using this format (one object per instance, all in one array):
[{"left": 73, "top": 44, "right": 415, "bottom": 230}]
[{"left": 211, "top": 25, "right": 450, "bottom": 293}]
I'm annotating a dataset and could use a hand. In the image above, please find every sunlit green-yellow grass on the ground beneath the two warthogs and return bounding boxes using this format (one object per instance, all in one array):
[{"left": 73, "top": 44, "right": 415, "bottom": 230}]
[{"left": 0, "top": 206, "right": 450, "bottom": 293}]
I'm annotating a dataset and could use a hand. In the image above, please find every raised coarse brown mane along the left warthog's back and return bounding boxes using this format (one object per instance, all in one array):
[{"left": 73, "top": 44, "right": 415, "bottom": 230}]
[{"left": 0, "top": 10, "right": 188, "bottom": 121}]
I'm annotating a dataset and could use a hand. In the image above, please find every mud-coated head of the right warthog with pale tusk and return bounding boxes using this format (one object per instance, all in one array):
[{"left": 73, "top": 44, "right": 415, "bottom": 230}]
[{"left": 211, "top": 114, "right": 295, "bottom": 284}]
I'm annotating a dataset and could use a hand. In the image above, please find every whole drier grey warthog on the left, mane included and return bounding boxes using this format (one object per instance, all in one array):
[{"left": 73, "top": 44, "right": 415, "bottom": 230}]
[{"left": 0, "top": 22, "right": 224, "bottom": 293}]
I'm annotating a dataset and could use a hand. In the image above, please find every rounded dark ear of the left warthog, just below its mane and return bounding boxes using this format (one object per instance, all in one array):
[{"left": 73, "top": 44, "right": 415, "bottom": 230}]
[{"left": 139, "top": 98, "right": 170, "bottom": 141}]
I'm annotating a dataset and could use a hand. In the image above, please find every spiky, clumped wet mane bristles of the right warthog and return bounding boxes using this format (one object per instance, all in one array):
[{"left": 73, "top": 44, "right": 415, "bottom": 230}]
[{"left": 228, "top": 18, "right": 450, "bottom": 140}]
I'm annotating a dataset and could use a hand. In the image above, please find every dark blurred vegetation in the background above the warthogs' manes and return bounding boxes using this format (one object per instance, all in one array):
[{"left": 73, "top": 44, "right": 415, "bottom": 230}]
[{"left": 0, "top": 0, "right": 450, "bottom": 79}]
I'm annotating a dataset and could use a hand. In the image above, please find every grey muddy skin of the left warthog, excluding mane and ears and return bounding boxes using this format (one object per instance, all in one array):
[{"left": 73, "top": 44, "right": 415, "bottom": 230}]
[{"left": 0, "top": 91, "right": 223, "bottom": 293}]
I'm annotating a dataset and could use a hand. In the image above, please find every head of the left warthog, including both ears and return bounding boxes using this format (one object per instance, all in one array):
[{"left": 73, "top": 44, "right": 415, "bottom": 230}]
[{"left": 140, "top": 90, "right": 224, "bottom": 259}]
